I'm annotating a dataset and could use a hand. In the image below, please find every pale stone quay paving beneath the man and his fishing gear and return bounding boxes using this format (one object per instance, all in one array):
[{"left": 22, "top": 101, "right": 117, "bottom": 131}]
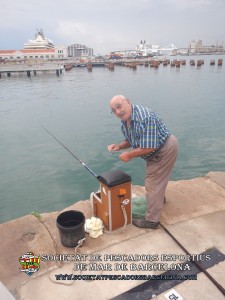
[{"left": 0, "top": 172, "right": 225, "bottom": 300}]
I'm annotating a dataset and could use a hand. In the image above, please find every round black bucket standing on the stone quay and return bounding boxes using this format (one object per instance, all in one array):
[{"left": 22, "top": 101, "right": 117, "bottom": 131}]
[{"left": 56, "top": 210, "right": 85, "bottom": 247}]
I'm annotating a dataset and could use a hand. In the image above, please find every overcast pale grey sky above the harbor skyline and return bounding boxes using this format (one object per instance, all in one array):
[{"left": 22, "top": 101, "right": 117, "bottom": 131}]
[{"left": 0, "top": 0, "right": 225, "bottom": 54}]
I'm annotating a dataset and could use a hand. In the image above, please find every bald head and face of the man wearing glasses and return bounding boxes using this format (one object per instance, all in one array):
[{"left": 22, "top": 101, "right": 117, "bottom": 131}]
[{"left": 110, "top": 96, "right": 132, "bottom": 121}]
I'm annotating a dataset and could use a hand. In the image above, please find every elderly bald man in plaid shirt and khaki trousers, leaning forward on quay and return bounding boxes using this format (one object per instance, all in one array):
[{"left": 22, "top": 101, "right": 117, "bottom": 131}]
[{"left": 108, "top": 95, "right": 178, "bottom": 229}]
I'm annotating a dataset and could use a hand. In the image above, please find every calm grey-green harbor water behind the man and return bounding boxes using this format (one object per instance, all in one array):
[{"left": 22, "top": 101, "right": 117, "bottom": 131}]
[{"left": 0, "top": 55, "right": 225, "bottom": 223}]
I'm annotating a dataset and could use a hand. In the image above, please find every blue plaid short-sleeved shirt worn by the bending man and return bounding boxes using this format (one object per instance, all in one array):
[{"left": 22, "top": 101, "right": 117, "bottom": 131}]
[{"left": 121, "top": 105, "right": 170, "bottom": 159}]
